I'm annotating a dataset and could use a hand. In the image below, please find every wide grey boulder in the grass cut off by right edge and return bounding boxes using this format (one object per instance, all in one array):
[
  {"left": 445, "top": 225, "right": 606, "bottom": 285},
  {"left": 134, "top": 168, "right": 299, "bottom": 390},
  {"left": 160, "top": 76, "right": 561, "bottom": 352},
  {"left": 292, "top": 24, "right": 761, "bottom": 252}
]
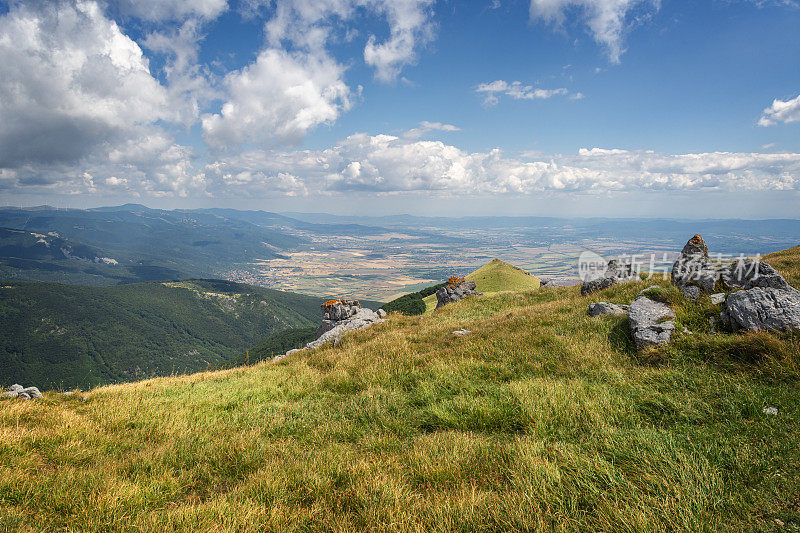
[{"left": 723, "top": 287, "right": 800, "bottom": 331}]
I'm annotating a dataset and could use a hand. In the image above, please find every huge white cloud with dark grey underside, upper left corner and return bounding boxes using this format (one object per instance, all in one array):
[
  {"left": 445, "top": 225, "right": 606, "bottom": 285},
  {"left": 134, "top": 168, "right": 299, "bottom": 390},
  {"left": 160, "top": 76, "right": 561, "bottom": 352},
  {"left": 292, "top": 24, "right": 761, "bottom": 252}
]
[{"left": 0, "top": 1, "right": 172, "bottom": 168}]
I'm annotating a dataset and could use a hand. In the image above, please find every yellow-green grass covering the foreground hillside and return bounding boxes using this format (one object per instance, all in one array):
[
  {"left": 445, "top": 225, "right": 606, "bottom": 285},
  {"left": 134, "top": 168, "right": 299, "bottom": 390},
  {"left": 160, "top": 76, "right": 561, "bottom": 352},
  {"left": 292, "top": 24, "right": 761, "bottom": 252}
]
[{"left": 0, "top": 268, "right": 800, "bottom": 532}]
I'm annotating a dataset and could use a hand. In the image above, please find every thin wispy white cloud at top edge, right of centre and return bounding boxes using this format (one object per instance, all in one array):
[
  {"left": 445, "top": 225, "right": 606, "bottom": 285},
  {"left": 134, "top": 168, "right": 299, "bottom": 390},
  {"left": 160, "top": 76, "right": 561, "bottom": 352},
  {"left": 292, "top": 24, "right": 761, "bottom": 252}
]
[{"left": 530, "top": 0, "right": 660, "bottom": 63}]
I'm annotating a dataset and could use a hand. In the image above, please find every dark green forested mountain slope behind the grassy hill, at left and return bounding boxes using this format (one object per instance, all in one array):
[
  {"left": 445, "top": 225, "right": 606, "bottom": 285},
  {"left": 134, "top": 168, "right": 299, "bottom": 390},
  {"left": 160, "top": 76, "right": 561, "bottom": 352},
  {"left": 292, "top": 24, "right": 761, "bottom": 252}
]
[{"left": 0, "top": 281, "right": 320, "bottom": 389}]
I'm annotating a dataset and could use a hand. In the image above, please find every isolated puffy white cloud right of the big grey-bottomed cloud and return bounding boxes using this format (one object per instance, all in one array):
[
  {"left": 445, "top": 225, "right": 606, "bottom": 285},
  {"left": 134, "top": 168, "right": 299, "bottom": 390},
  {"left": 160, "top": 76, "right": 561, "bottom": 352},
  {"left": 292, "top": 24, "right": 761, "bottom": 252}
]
[{"left": 202, "top": 48, "right": 350, "bottom": 148}]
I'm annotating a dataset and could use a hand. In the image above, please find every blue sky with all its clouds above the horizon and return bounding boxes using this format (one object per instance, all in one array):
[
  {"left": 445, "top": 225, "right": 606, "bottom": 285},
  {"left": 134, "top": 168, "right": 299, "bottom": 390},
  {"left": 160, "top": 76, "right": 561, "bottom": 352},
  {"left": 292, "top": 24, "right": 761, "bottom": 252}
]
[{"left": 0, "top": 0, "right": 800, "bottom": 218}]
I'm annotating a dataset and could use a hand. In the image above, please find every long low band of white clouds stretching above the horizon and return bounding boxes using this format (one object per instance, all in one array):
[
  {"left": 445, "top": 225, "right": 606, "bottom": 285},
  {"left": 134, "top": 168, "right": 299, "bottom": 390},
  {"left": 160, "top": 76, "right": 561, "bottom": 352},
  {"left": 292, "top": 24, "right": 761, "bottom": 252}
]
[{"left": 206, "top": 134, "right": 800, "bottom": 196}]
